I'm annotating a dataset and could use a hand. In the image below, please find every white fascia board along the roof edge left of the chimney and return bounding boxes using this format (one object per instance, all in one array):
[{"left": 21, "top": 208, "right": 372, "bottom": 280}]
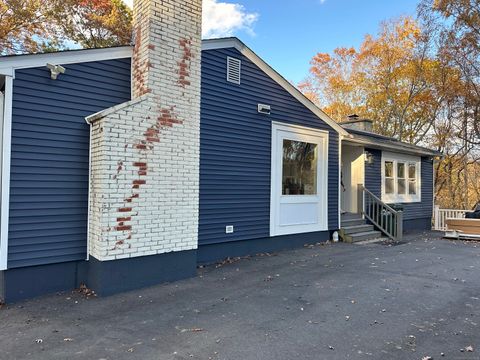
[{"left": 0, "top": 46, "right": 133, "bottom": 76}]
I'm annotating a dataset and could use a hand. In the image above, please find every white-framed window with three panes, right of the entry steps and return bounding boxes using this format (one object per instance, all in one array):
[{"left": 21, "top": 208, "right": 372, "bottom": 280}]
[{"left": 382, "top": 152, "right": 421, "bottom": 203}]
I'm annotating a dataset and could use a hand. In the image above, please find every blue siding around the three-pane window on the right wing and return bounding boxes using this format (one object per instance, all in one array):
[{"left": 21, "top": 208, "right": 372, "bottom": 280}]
[{"left": 365, "top": 149, "right": 433, "bottom": 224}]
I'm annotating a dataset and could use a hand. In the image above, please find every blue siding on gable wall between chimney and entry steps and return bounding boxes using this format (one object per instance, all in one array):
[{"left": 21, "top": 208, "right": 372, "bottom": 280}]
[{"left": 199, "top": 49, "right": 338, "bottom": 245}]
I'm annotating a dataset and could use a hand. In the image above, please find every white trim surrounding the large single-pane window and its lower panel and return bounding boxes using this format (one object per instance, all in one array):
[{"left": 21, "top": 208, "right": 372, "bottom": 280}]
[{"left": 270, "top": 122, "right": 329, "bottom": 236}]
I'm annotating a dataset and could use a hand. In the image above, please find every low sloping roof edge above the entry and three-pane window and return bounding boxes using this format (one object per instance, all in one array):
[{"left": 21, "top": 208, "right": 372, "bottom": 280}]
[{"left": 344, "top": 129, "right": 442, "bottom": 156}]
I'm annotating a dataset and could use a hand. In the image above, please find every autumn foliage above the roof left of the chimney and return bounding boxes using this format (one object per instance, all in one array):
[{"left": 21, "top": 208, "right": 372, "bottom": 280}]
[{"left": 0, "top": 0, "right": 132, "bottom": 55}]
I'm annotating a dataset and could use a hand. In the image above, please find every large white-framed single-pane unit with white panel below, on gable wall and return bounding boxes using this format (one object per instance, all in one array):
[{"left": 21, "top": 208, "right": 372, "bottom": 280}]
[{"left": 270, "top": 123, "right": 328, "bottom": 236}]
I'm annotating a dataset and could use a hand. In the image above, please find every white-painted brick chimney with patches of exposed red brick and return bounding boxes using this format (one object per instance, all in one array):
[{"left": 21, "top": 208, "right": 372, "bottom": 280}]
[{"left": 87, "top": 0, "right": 202, "bottom": 261}]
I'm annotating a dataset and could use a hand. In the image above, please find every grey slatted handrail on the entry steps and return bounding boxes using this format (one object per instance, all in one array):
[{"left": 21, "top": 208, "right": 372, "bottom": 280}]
[{"left": 357, "top": 184, "right": 403, "bottom": 241}]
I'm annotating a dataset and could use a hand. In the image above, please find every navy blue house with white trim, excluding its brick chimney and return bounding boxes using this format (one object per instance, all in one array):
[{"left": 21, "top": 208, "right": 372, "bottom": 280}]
[{"left": 0, "top": 38, "right": 438, "bottom": 301}]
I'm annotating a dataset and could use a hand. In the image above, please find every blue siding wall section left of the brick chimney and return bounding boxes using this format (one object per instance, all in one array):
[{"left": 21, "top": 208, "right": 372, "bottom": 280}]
[{"left": 8, "top": 59, "right": 130, "bottom": 268}]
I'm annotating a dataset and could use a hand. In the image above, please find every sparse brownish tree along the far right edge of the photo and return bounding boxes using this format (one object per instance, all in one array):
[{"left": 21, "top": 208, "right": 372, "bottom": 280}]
[{"left": 419, "top": 0, "right": 480, "bottom": 208}]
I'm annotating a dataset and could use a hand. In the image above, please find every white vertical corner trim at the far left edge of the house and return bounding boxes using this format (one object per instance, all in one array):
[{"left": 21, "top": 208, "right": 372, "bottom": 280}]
[{"left": 0, "top": 76, "right": 13, "bottom": 270}]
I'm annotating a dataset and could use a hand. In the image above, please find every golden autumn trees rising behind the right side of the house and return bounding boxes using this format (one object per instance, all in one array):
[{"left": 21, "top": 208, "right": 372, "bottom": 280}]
[{"left": 300, "top": 13, "right": 480, "bottom": 208}]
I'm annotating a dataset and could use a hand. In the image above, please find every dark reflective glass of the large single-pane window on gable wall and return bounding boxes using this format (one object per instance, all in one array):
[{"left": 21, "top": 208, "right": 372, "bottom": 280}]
[{"left": 282, "top": 139, "right": 318, "bottom": 195}]
